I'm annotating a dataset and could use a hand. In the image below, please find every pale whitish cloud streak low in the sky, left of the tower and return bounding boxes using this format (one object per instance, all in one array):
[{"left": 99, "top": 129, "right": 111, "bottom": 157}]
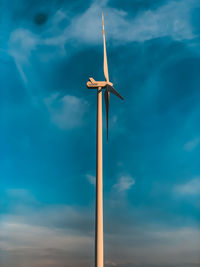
[{"left": 1, "top": 221, "right": 91, "bottom": 251}]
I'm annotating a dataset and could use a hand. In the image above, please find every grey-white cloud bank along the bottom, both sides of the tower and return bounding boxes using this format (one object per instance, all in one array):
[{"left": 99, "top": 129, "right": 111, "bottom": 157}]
[{"left": 0, "top": 189, "right": 200, "bottom": 267}]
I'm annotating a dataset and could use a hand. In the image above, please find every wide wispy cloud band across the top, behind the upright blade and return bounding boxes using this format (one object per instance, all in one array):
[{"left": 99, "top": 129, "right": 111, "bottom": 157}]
[{"left": 8, "top": 0, "right": 199, "bottom": 83}]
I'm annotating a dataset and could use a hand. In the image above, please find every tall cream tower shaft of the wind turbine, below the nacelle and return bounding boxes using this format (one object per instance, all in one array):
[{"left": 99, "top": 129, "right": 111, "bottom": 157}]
[{"left": 95, "top": 87, "right": 104, "bottom": 267}]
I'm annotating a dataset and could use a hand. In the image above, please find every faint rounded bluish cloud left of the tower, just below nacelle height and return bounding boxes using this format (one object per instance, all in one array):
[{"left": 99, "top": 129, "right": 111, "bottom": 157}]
[{"left": 44, "top": 94, "right": 89, "bottom": 130}]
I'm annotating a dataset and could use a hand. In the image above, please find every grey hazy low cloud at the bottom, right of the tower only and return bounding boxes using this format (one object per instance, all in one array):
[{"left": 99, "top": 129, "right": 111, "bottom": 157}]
[{"left": 106, "top": 224, "right": 199, "bottom": 267}]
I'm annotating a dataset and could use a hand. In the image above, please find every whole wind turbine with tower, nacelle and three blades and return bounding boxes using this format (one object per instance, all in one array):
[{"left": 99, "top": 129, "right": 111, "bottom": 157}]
[{"left": 87, "top": 12, "right": 123, "bottom": 267}]
